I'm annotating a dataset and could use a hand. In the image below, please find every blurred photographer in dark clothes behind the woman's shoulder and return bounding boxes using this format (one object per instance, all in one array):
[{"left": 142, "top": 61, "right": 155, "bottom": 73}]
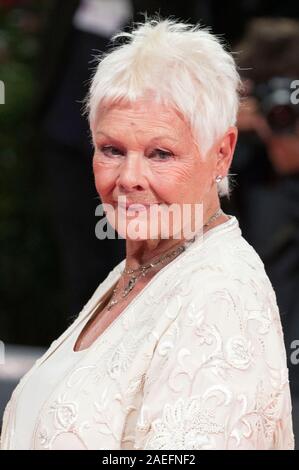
[{"left": 230, "top": 18, "right": 299, "bottom": 393}]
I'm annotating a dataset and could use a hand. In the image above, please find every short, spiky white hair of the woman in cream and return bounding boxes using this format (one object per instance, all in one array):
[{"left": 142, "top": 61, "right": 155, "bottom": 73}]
[{"left": 85, "top": 17, "right": 241, "bottom": 196}]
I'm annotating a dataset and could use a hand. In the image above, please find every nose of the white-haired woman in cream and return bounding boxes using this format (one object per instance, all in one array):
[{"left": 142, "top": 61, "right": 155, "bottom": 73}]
[{"left": 117, "top": 152, "right": 148, "bottom": 192}]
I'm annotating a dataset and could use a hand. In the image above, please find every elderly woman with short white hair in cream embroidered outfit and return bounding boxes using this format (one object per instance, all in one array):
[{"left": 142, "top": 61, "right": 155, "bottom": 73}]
[{"left": 1, "top": 19, "right": 294, "bottom": 450}]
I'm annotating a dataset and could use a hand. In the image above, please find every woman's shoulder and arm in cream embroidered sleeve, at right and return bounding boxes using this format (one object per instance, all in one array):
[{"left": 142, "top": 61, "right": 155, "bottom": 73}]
[{"left": 141, "top": 229, "right": 293, "bottom": 449}]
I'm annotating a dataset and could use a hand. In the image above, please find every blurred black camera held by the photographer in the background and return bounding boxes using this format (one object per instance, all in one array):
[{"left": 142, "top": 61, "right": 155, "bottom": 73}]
[{"left": 253, "top": 77, "right": 299, "bottom": 134}]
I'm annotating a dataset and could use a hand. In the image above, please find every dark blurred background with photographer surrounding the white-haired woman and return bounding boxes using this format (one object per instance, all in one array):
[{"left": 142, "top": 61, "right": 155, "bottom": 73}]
[{"left": 0, "top": 0, "right": 299, "bottom": 448}]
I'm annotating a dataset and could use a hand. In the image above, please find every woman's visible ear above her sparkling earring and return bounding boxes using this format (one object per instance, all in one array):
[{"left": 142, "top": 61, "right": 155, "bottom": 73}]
[{"left": 215, "top": 126, "right": 238, "bottom": 177}]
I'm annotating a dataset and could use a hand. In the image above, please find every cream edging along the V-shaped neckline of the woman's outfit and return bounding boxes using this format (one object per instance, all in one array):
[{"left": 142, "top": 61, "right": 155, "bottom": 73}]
[{"left": 71, "top": 214, "right": 239, "bottom": 355}]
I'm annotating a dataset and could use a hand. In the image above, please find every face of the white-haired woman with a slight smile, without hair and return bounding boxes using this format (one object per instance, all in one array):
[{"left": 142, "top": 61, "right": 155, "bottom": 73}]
[{"left": 92, "top": 99, "right": 232, "bottom": 239}]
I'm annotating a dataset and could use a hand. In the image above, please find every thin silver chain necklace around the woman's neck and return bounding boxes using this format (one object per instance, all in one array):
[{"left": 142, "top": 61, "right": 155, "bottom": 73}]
[{"left": 107, "top": 208, "right": 223, "bottom": 310}]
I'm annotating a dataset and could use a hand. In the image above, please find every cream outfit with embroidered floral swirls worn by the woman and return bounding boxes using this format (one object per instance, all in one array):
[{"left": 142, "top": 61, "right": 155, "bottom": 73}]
[{"left": 1, "top": 216, "right": 294, "bottom": 450}]
